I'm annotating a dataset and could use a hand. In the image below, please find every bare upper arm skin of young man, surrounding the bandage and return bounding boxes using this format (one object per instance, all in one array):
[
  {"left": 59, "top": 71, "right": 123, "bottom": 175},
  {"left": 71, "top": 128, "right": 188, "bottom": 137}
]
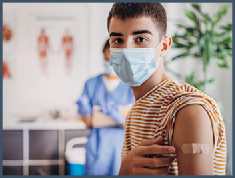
[{"left": 173, "top": 105, "right": 214, "bottom": 175}]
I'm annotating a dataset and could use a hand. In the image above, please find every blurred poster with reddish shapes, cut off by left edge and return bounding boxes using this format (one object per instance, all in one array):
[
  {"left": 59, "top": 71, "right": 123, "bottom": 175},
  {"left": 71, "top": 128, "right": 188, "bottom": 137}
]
[{"left": 2, "top": 12, "right": 16, "bottom": 79}]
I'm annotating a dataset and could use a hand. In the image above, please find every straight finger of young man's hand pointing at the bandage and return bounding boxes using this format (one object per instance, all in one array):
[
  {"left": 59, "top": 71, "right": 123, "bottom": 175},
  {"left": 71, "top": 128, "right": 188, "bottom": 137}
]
[{"left": 134, "top": 145, "right": 175, "bottom": 155}]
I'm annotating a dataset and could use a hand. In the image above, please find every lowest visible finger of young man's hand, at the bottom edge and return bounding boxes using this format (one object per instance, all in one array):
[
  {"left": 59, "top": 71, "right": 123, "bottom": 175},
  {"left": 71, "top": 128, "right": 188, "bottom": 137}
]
[{"left": 133, "top": 167, "right": 169, "bottom": 175}]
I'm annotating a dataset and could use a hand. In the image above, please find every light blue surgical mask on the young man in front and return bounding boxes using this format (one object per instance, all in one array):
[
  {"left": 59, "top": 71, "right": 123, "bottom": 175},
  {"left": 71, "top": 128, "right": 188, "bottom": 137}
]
[{"left": 110, "top": 40, "right": 163, "bottom": 86}]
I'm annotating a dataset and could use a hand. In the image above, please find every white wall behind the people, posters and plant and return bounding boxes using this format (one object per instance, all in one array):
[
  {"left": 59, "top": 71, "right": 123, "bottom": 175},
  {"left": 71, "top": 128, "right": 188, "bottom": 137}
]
[{"left": 3, "top": 3, "right": 232, "bottom": 174}]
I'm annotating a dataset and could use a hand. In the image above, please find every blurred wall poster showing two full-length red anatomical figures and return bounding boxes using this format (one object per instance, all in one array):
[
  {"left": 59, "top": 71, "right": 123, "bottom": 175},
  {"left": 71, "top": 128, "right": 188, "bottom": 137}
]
[{"left": 29, "top": 12, "right": 88, "bottom": 77}]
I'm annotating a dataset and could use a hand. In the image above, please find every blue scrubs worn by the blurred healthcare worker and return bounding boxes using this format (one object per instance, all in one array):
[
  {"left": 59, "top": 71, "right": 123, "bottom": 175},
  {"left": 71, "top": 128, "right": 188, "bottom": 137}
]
[{"left": 77, "top": 74, "right": 135, "bottom": 175}]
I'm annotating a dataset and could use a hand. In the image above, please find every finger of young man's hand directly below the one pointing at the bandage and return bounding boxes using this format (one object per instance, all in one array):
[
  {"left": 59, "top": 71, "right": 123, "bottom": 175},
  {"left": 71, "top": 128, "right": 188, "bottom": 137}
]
[{"left": 132, "top": 157, "right": 173, "bottom": 168}]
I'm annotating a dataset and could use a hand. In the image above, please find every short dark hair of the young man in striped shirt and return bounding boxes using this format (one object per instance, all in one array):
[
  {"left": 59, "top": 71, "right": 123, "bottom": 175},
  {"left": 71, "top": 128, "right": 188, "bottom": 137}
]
[{"left": 107, "top": 3, "right": 167, "bottom": 40}]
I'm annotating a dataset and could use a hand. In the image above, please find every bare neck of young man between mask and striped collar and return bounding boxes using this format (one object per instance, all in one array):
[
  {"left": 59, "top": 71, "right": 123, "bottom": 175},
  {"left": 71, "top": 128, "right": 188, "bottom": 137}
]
[{"left": 131, "top": 67, "right": 169, "bottom": 101}]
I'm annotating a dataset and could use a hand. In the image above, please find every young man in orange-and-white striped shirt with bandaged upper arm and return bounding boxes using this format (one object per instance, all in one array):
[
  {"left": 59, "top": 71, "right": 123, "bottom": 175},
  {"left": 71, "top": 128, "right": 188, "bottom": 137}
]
[{"left": 107, "top": 3, "right": 226, "bottom": 175}]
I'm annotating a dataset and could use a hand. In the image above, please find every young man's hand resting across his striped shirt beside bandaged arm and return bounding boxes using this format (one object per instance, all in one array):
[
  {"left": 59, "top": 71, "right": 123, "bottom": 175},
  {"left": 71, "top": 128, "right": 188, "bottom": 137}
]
[{"left": 119, "top": 136, "right": 175, "bottom": 175}]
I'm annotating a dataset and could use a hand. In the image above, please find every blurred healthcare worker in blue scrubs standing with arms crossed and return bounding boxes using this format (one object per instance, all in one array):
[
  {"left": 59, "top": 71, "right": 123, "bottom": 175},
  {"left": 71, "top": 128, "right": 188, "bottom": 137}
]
[{"left": 77, "top": 40, "right": 135, "bottom": 175}]
